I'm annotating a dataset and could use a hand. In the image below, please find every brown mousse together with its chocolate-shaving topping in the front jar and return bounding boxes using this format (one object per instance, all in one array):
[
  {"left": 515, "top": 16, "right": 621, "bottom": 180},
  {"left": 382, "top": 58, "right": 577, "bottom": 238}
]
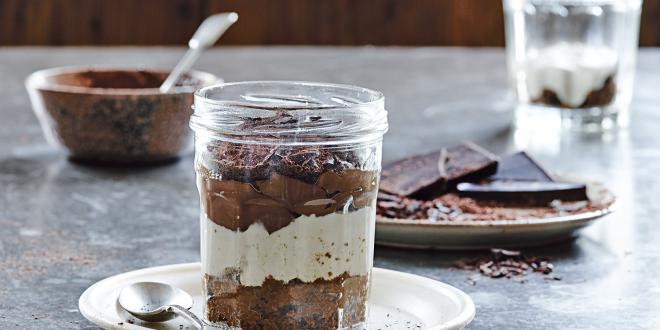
[{"left": 198, "top": 124, "right": 378, "bottom": 233}]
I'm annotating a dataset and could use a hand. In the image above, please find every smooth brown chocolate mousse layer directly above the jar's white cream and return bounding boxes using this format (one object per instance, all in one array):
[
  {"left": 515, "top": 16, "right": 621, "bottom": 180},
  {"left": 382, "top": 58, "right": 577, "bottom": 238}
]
[{"left": 200, "top": 170, "right": 377, "bottom": 233}]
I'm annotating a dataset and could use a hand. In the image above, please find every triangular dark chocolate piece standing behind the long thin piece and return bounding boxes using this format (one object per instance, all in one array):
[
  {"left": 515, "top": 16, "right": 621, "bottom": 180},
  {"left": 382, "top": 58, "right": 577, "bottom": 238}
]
[{"left": 490, "top": 151, "right": 555, "bottom": 182}]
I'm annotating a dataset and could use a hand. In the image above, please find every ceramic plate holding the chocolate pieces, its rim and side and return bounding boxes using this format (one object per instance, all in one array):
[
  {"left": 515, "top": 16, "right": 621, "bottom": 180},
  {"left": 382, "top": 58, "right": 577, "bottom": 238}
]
[{"left": 376, "top": 180, "right": 615, "bottom": 250}]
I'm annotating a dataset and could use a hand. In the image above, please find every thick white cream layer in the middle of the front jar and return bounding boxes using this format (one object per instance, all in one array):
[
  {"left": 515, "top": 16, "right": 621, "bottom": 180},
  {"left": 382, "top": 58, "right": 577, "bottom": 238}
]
[{"left": 201, "top": 207, "right": 376, "bottom": 286}]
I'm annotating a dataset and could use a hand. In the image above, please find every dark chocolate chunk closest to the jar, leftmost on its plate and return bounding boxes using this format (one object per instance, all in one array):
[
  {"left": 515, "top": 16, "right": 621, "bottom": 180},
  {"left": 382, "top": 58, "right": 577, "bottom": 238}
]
[{"left": 380, "top": 148, "right": 447, "bottom": 196}]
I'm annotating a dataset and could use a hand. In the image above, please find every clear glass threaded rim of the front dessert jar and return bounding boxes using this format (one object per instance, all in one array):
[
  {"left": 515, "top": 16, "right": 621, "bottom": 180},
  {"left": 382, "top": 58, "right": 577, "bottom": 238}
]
[{"left": 190, "top": 80, "right": 388, "bottom": 145}]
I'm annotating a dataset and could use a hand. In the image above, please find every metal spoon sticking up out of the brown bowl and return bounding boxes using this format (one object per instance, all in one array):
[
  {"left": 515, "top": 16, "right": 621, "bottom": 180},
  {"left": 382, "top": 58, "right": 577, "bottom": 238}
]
[{"left": 160, "top": 12, "right": 238, "bottom": 93}]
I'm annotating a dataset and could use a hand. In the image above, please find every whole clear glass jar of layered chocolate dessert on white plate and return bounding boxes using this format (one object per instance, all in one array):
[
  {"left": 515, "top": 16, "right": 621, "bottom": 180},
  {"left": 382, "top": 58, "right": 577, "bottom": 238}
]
[{"left": 191, "top": 81, "right": 387, "bottom": 329}]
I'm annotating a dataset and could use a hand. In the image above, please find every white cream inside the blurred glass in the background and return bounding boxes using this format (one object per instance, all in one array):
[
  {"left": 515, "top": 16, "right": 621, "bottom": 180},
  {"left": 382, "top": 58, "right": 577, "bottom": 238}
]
[{"left": 525, "top": 42, "right": 618, "bottom": 107}]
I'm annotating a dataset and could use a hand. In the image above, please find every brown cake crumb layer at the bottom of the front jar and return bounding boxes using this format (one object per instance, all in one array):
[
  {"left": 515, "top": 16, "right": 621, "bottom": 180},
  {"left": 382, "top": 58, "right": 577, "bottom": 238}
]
[{"left": 204, "top": 273, "right": 369, "bottom": 330}]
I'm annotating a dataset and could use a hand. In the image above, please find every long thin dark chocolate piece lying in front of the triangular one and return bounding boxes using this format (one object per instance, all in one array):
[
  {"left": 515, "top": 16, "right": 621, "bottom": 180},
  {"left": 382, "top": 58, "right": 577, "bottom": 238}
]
[{"left": 456, "top": 181, "right": 588, "bottom": 206}]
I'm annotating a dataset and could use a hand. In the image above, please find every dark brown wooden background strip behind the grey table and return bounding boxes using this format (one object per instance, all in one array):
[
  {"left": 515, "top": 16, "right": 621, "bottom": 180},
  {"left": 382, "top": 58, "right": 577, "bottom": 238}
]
[{"left": 0, "top": 0, "right": 660, "bottom": 46}]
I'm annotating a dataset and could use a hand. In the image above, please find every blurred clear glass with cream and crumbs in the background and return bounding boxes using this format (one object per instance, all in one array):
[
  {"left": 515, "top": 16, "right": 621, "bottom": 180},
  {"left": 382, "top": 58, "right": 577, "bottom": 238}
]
[{"left": 503, "top": 0, "right": 642, "bottom": 130}]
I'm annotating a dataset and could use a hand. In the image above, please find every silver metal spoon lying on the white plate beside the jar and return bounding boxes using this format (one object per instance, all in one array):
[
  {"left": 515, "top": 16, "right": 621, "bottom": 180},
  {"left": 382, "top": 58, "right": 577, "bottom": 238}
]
[{"left": 118, "top": 282, "right": 204, "bottom": 329}]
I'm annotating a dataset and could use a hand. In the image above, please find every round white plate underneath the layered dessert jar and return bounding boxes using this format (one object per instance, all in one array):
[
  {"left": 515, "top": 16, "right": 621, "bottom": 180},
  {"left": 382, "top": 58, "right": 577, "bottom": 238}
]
[{"left": 78, "top": 263, "right": 475, "bottom": 330}]
